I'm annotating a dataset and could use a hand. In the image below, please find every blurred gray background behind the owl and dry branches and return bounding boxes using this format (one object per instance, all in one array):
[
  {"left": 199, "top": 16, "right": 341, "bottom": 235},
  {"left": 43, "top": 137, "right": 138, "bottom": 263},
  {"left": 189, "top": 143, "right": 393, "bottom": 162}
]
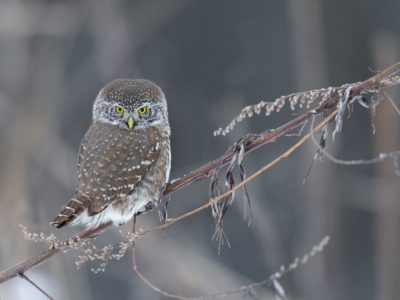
[{"left": 0, "top": 0, "right": 400, "bottom": 300}]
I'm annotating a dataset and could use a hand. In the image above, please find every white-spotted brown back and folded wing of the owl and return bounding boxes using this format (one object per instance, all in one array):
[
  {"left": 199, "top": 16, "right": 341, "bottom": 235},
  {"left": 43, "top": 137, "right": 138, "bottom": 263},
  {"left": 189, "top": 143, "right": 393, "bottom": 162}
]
[{"left": 77, "top": 123, "right": 161, "bottom": 215}]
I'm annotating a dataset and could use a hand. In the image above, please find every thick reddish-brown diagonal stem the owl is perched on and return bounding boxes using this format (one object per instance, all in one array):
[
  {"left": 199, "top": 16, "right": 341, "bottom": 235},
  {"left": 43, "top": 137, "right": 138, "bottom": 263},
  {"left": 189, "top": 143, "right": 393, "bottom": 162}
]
[{"left": 0, "top": 62, "right": 400, "bottom": 283}]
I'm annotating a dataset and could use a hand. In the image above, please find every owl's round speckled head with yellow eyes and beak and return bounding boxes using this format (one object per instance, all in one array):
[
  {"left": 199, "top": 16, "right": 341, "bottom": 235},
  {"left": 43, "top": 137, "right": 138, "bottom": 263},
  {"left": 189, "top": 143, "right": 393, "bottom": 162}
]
[{"left": 93, "top": 79, "right": 169, "bottom": 130}]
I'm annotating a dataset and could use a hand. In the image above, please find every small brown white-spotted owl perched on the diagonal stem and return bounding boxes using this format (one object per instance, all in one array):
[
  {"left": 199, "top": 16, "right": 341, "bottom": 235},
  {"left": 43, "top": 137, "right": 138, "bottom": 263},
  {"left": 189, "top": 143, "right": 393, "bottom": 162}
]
[{"left": 51, "top": 79, "right": 171, "bottom": 228}]
